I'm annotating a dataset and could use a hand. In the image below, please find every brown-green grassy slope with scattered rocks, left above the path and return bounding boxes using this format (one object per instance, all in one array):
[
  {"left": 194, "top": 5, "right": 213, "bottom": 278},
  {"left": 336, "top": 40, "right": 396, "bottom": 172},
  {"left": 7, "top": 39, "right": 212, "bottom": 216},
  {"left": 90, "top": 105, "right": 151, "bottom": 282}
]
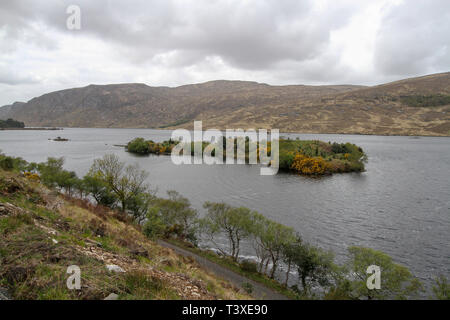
[{"left": 0, "top": 170, "right": 249, "bottom": 300}]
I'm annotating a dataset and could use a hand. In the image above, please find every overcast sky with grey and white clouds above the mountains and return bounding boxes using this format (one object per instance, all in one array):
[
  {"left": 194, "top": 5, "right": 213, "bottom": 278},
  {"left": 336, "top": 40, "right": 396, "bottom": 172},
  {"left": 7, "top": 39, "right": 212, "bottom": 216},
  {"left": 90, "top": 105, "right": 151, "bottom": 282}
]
[{"left": 0, "top": 0, "right": 450, "bottom": 105}]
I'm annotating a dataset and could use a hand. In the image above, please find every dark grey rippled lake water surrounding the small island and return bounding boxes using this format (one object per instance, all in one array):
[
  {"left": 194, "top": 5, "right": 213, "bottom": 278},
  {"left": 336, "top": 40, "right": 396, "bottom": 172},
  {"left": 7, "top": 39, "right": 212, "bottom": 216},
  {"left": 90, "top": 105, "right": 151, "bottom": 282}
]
[{"left": 0, "top": 129, "right": 450, "bottom": 296}]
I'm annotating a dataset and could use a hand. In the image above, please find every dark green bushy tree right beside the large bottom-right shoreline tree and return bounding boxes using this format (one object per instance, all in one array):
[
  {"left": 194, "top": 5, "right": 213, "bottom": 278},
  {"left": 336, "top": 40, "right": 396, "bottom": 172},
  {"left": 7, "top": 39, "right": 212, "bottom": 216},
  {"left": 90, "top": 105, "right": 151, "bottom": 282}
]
[{"left": 292, "top": 243, "right": 333, "bottom": 295}]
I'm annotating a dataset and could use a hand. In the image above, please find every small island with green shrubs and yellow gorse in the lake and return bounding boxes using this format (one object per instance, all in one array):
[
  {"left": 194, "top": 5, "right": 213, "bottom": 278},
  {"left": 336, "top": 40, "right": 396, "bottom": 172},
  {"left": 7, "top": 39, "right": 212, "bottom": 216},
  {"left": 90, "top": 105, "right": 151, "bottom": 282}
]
[{"left": 125, "top": 138, "right": 367, "bottom": 176}]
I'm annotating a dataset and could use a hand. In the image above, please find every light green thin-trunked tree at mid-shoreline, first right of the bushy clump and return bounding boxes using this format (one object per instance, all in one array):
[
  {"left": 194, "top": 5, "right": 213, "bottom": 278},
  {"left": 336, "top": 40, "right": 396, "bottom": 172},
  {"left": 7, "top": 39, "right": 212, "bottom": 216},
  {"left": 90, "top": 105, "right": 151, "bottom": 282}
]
[{"left": 201, "top": 202, "right": 252, "bottom": 261}]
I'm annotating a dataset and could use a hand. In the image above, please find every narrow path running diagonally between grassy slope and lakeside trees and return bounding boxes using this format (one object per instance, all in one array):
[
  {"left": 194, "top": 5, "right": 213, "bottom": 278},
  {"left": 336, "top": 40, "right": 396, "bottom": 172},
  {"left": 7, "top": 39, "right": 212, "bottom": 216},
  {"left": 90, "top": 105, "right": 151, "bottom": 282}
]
[{"left": 158, "top": 240, "right": 288, "bottom": 300}]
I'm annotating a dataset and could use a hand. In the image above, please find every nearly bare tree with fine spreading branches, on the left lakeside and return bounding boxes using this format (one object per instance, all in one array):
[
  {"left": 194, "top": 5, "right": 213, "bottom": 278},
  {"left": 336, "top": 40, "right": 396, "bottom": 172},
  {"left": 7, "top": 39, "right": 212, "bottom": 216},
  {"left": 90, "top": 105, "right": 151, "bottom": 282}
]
[{"left": 89, "top": 154, "right": 148, "bottom": 212}]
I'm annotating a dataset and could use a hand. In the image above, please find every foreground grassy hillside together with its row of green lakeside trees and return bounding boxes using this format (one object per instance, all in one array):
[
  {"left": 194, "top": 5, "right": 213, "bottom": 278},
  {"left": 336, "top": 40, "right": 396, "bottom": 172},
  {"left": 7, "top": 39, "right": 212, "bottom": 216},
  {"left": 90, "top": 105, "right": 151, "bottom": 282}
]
[{"left": 0, "top": 152, "right": 450, "bottom": 300}]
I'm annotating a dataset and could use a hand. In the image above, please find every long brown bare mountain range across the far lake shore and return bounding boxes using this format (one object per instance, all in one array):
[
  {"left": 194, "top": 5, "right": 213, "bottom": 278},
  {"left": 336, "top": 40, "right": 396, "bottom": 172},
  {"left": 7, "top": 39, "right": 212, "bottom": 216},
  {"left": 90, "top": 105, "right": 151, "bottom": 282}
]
[{"left": 0, "top": 73, "right": 450, "bottom": 136}]
